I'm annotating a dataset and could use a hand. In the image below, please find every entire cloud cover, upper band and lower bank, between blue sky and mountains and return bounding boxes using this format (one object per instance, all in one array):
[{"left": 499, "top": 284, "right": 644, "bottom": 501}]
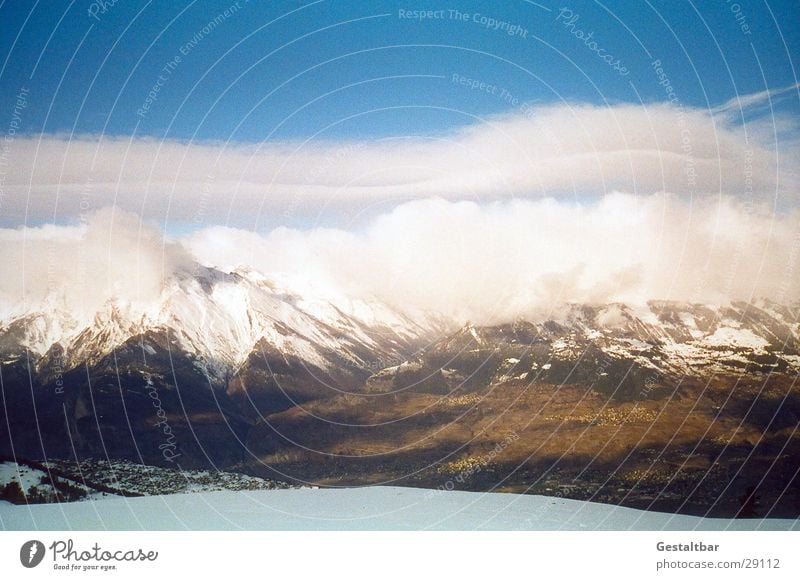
[{"left": 0, "top": 94, "right": 800, "bottom": 322}]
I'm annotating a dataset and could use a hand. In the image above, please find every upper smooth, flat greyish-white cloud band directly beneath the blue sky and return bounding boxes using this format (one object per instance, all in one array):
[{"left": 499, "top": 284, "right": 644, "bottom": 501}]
[{"left": 0, "top": 95, "right": 800, "bottom": 228}]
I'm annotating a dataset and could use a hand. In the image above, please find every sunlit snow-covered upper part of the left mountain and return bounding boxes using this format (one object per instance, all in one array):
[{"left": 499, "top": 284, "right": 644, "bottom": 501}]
[{"left": 0, "top": 266, "right": 439, "bottom": 377}]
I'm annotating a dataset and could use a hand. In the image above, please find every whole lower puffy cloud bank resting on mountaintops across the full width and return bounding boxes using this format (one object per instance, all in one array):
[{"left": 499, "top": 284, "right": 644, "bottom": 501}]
[{"left": 0, "top": 193, "right": 800, "bottom": 323}]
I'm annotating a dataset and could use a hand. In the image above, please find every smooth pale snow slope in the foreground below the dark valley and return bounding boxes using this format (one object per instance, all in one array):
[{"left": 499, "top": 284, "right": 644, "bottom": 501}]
[{"left": 0, "top": 487, "right": 800, "bottom": 530}]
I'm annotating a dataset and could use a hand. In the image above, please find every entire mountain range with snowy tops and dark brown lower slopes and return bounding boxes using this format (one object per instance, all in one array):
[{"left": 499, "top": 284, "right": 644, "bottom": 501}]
[{"left": 0, "top": 266, "right": 800, "bottom": 515}]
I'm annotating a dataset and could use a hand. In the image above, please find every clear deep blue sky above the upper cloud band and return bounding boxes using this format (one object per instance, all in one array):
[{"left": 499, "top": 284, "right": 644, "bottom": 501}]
[{"left": 0, "top": 0, "right": 800, "bottom": 141}]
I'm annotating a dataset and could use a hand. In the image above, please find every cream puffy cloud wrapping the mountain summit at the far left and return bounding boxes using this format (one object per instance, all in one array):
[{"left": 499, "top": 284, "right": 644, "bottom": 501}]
[{"left": 0, "top": 209, "right": 192, "bottom": 319}]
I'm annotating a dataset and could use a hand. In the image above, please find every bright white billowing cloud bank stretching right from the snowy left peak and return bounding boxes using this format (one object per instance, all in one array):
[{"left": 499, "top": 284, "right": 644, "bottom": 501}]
[{"left": 184, "top": 194, "right": 800, "bottom": 322}]
